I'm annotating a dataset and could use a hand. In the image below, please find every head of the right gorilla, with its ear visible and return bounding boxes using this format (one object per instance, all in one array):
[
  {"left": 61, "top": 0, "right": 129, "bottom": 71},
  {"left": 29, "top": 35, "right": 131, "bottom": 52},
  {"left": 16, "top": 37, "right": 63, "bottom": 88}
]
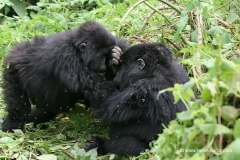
[{"left": 114, "top": 43, "right": 172, "bottom": 89}]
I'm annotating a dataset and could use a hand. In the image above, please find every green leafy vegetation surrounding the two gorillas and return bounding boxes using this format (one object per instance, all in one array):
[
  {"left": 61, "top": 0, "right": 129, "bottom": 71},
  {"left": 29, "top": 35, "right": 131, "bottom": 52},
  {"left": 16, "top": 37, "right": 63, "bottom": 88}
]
[{"left": 0, "top": 0, "right": 240, "bottom": 160}]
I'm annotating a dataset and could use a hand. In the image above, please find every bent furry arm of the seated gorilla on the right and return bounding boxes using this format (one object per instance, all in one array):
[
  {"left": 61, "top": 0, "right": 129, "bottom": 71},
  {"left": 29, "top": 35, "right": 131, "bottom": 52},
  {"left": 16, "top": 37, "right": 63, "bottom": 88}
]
[{"left": 93, "top": 79, "right": 153, "bottom": 123}]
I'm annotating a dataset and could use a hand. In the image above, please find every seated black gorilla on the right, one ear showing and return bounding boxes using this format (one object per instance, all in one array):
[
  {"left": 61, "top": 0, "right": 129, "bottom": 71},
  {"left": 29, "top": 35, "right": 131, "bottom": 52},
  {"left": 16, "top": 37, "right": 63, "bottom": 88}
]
[{"left": 85, "top": 44, "right": 189, "bottom": 156}]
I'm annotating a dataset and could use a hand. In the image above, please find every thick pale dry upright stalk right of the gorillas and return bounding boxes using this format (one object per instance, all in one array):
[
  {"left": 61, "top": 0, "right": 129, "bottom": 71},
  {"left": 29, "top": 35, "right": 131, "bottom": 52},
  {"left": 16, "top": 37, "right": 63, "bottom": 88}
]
[{"left": 195, "top": 8, "right": 203, "bottom": 76}]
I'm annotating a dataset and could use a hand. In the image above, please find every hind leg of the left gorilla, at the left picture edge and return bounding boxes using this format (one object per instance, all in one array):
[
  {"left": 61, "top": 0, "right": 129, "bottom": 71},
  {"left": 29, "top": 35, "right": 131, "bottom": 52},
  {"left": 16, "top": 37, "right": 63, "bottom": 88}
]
[{"left": 2, "top": 68, "right": 31, "bottom": 132}]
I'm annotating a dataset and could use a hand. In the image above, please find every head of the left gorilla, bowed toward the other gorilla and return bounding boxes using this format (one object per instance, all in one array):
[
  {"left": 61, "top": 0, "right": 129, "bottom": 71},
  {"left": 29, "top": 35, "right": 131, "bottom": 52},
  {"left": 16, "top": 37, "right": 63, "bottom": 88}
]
[{"left": 75, "top": 22, "right": 117, "bottom": 75}]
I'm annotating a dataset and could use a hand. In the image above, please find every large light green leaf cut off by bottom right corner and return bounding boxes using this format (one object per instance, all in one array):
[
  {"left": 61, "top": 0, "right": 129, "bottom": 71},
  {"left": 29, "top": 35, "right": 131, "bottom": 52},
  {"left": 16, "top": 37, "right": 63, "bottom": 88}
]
[{"left": 222, "top": 138, "right": 240, "bottom": 160}]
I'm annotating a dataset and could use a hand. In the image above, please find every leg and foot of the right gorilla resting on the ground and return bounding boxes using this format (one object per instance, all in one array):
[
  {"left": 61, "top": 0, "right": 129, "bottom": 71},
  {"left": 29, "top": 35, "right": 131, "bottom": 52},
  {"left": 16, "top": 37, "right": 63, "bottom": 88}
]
[{"left": 84, "top": 136, "right": 149, "bottom": 156}]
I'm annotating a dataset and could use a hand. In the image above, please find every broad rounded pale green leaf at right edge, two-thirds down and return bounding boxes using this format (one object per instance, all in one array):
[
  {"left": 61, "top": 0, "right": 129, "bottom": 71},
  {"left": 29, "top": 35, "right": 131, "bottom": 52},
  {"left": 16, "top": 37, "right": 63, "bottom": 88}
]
[{"left": 221, "top": 106, "right": 240, "bottom": 121}]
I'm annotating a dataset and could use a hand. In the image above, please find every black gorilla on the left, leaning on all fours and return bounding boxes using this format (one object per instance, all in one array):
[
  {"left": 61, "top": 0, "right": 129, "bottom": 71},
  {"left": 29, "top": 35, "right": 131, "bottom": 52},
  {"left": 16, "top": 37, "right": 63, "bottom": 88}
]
[{"left": 2, "top": 22, "right": 128, "bottom": 131}]
